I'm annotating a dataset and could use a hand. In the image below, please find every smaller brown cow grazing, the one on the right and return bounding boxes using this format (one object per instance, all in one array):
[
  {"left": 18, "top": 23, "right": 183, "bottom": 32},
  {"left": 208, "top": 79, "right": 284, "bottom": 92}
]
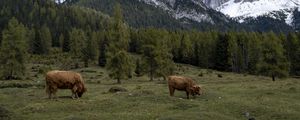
[{"left": 168, "top": 76, "right": 202, "bottom": 99}]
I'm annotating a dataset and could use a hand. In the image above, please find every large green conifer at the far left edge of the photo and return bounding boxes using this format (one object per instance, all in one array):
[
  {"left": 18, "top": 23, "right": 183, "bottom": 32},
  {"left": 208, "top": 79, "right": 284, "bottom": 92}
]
[{"left": 0, "top": 18, "right": 27, "bottom": 80}]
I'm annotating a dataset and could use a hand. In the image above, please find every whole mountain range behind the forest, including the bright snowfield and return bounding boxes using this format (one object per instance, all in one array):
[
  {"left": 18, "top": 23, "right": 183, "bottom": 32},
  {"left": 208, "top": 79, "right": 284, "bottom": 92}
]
[{"left": 64, "top": 0, "right": 300, "bottom": 32}]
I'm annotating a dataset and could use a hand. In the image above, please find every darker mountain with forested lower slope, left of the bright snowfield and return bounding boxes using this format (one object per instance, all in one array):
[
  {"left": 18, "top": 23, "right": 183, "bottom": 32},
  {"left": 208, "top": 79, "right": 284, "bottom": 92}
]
[{"left": 66, "top": 0, "right": 238, "bottom": 30}]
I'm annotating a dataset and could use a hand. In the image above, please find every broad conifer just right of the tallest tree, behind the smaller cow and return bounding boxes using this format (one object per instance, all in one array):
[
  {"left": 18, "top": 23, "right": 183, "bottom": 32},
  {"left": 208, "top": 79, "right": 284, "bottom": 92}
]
[{"left": 142, "top": 29, "right": 174, "bottom": 81}]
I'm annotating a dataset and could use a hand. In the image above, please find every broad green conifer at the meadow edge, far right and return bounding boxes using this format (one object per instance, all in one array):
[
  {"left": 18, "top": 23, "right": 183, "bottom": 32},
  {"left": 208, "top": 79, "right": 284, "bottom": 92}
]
[{"left": 257, "top": 32, "right": 289, "bottom": 81}]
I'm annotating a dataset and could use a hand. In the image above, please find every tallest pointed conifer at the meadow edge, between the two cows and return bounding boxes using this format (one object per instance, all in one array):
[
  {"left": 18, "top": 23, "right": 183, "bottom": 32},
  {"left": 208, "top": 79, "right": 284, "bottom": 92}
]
[{"left": 106, "top": 3, "right": 134, "bottom": 84}]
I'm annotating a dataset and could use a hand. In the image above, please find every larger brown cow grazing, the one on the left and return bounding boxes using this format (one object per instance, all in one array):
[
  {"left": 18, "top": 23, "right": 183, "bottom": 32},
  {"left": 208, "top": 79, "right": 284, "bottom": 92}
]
[{"left": 46, "top": 70, "right": 86, "bottom": 99}]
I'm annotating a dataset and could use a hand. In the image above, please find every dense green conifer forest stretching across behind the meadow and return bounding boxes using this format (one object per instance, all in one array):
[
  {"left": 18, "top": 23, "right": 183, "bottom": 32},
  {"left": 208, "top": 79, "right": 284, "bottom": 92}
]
[{"left": 0, "top": 0, "right": 300, "bottom": 83}]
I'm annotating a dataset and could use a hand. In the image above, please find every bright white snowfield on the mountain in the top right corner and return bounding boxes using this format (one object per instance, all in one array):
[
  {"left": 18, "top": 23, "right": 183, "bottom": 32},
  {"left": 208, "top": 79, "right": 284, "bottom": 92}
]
[{"left": 216, "top": 0, "right": 300, "bottom": 24}]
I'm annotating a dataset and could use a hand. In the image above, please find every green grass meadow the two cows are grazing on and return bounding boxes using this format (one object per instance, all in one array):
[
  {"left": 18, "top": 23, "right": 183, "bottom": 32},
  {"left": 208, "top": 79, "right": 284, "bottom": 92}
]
[{"left": 0, "top": 65, "right": 300, "bottom": 120}]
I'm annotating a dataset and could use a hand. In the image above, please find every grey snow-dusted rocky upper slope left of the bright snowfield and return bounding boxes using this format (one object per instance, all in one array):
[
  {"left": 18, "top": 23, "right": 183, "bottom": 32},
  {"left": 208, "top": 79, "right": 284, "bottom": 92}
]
[{"left": 139, "top": 0, "right": 228, "bottom": 24}]
